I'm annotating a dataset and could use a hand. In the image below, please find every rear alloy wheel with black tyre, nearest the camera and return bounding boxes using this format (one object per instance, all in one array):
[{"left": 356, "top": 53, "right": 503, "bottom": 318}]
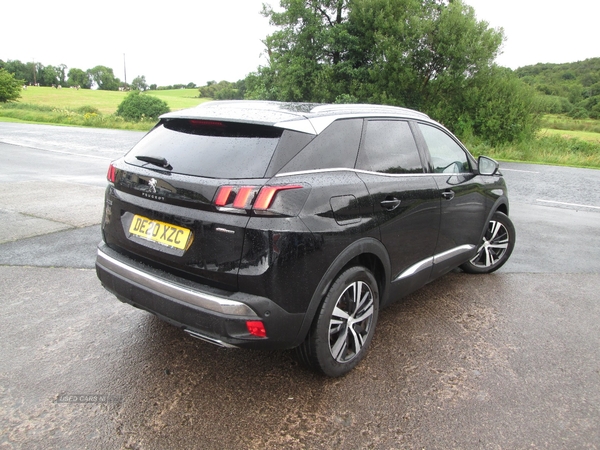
[{"left": 298, "top": 266, "right": 379, "bottom": 377}]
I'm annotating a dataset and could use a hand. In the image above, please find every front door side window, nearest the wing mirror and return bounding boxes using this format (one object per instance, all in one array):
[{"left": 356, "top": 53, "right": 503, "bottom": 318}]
[{"left": 419, "top": 123, "right": 471, "bottom": 173}]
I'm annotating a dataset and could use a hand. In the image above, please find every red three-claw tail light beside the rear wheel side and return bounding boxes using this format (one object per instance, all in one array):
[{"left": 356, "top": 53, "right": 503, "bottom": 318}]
[{"left": 214, "top": 184, "right": 304, "bottom": 213}]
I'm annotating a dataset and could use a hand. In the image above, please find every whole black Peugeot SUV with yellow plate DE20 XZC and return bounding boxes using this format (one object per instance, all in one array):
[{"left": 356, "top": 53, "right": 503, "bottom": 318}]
[{"left": 96, "top": 101, "right": 515, "bottom": 376}]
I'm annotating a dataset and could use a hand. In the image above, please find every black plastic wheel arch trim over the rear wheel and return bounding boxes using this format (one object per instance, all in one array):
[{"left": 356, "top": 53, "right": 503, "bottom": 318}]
[{"left": 295, "top": 238, "right": 391, "bottom": 345}]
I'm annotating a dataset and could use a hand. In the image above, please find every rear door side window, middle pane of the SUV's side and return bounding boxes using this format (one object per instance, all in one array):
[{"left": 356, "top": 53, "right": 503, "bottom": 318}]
[{"left": 357, "top": 120, "right": 423, "bottom": 173}]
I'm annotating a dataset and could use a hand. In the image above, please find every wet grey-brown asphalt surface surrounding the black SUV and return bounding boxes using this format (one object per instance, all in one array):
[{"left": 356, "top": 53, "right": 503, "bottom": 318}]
[{"left": 0, "top": 123, "right": 600, "bottom": 449}]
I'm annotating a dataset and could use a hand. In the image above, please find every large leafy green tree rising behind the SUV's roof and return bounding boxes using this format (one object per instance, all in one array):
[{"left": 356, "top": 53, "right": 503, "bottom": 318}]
[{"left": 245, "top": 0, "right": 533, "bottom": 142}]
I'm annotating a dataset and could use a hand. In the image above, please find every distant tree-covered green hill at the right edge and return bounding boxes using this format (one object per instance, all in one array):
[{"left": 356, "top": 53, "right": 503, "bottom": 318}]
[{"left": 515, "top": 58, "right": 600, "bottom": 119}]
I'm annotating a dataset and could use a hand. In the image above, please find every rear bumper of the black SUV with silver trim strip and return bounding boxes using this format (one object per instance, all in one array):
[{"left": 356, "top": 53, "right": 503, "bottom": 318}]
[{"left": 96, "top": 243, "right": 304, "bottom": 349}]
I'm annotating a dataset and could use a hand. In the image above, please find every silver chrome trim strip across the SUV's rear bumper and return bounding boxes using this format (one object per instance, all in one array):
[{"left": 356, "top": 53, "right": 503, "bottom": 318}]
[{"left": 96, "top": 249, "right": 257, "bottom": 317}]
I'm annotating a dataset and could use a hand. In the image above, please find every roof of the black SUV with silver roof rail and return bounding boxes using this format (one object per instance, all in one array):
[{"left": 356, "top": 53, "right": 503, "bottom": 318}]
[{"left": 161, "top": 100, "right": 431, "bottom": 134}]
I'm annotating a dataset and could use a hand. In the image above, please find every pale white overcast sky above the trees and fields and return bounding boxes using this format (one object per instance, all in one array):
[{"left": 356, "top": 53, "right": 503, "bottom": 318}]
[{"left": 0, "top": 0, "right": 600, "bottom": 86}]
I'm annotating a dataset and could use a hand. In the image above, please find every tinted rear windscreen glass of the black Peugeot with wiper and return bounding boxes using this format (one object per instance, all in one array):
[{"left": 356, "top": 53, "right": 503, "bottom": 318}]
[{"left": 125, "top": 119, "right": 283, "bottom": 178}]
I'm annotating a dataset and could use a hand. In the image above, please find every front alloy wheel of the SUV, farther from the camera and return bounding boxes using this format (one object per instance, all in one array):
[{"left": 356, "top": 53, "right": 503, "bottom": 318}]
[{"left": 460, "top": 212, "right": 516, "bottom": 273}]
